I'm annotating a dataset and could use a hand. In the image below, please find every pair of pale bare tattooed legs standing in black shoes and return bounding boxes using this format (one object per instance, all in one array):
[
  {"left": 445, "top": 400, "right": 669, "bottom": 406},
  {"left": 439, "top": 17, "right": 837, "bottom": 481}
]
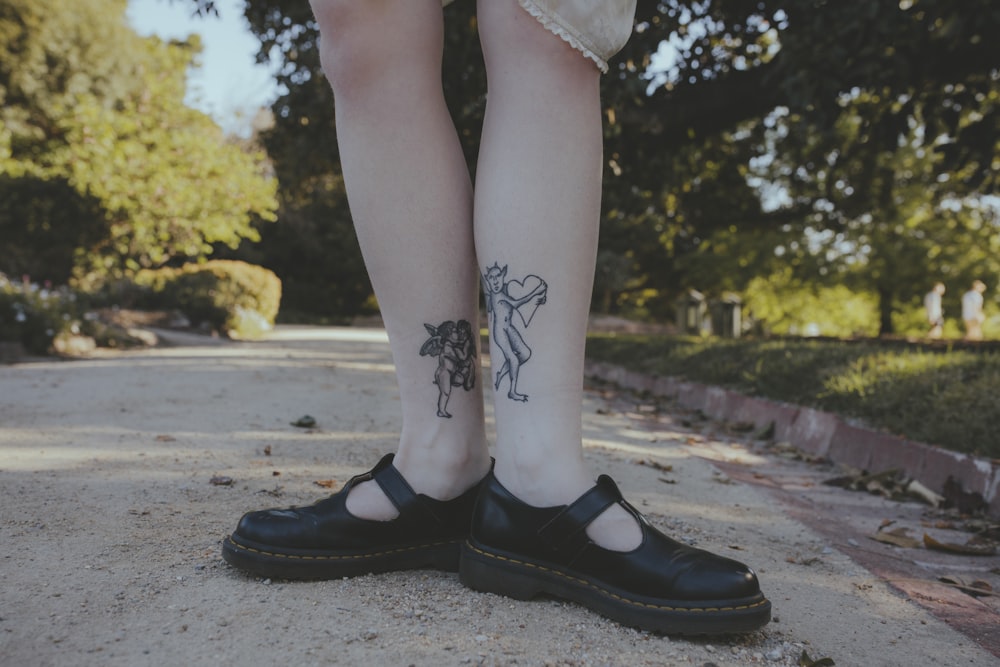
[{"left": 313, "top": 0, "right": 639, "bottom": 549}]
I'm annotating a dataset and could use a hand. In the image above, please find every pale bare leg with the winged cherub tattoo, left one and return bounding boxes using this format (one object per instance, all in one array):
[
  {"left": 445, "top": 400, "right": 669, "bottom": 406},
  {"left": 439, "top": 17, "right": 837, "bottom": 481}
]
[{"left": 312, "top": 0, "right": 489, "bottom": 519}]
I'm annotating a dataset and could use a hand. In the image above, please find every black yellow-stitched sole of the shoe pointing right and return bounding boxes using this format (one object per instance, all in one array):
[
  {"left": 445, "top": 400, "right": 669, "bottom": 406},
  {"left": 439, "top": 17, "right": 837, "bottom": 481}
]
[{"left": 458, "top": 542, "right": 771, "bottom": 635}]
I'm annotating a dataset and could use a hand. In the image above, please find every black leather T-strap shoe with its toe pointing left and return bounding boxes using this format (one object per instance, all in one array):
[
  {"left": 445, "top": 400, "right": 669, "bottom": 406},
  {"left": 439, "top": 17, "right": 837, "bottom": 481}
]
[{"left": 222, "top": 454, "right": 481, "bottom": 579}]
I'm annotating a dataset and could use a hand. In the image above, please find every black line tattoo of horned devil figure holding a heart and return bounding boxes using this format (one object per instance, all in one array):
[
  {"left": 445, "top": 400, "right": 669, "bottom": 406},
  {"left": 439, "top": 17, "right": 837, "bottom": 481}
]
[{"left": 483, "top": 263, "right": 549, "bottom": 403}]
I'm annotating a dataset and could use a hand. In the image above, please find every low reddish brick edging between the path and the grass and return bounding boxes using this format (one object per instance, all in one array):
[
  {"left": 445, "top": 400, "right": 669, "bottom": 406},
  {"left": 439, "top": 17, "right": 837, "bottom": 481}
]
[{"left": 586, "top": 361, "right": 1000, "bottom": 517}]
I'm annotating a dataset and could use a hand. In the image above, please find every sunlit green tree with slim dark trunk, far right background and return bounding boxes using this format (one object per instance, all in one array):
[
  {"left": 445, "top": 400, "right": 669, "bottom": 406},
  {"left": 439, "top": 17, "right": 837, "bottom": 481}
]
[{"left": 784, "top": 93, "right": 1000, "bottom": 335}]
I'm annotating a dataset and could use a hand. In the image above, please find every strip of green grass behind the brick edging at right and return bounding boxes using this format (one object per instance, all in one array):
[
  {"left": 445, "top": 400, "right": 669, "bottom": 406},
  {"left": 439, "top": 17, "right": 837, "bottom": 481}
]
[{"left": 587, "top": 334, "right": 1000, "bottom": 458}]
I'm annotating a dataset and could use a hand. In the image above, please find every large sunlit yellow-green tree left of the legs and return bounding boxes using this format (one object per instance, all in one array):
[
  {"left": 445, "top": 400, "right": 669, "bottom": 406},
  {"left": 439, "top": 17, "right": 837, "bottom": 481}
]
[{"left": 0, "top": 0, "right": 276, "bottom": 284}]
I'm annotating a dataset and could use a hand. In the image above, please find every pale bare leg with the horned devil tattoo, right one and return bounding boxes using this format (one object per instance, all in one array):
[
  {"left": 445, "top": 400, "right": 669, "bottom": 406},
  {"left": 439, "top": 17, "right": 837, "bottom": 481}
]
[{"left": 474, "top": 0, "right": 640, "bottom": 550}]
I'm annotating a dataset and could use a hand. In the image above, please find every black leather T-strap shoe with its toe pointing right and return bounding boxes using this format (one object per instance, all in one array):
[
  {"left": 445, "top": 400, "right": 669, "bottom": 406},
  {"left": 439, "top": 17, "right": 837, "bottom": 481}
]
[{"left": 459, "top": 473, "right": 771, "bottom": 634}]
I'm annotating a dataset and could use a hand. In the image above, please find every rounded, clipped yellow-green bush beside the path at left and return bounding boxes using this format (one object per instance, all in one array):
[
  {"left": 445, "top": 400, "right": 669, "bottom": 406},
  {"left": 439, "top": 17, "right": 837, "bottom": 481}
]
[{"left": 135, "top": 260, "right": 281, "bottom": 338}]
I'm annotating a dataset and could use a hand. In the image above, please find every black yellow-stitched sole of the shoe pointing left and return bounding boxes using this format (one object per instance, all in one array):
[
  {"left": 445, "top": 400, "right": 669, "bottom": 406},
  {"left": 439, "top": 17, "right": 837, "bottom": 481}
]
[{"left": 222, "top": 536, "right": 460, "bottom": 579}]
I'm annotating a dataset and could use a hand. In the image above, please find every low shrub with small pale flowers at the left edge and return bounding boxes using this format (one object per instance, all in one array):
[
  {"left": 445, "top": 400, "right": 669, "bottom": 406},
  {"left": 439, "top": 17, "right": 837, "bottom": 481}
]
[{"left": 0, "top": 273, "right": 77, "bottom": 354}]
